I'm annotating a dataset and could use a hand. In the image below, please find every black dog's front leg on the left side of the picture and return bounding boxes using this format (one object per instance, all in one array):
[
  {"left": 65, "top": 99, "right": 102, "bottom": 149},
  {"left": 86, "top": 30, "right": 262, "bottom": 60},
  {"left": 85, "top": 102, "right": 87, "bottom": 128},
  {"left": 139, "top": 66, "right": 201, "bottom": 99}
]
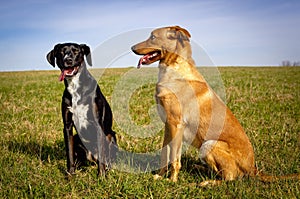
[{"left": 62, "top": 95, "right": 76, "bottom": 174}]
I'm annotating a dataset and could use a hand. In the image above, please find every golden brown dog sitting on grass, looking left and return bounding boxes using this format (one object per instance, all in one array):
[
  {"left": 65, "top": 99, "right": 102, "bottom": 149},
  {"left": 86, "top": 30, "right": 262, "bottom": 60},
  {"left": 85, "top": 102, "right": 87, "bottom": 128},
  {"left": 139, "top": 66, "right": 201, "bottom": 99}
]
[{"left": 132, "top": 26, "right": 299, "bottom": 185}]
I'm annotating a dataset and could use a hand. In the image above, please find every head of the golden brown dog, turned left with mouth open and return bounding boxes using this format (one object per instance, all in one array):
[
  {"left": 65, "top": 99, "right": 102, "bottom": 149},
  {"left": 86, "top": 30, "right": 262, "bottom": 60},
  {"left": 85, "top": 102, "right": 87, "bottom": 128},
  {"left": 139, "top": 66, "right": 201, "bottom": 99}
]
[{"left": 131, "top": 26, "right": 191, "bottom": 68}]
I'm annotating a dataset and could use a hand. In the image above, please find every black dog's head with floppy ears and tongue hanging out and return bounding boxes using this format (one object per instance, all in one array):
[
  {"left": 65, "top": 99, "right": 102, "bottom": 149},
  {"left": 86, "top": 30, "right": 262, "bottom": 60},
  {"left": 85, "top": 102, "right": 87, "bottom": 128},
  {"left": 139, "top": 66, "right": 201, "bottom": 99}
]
[{"left": 47, "top": 43, "right": 92, "bottom": 81}]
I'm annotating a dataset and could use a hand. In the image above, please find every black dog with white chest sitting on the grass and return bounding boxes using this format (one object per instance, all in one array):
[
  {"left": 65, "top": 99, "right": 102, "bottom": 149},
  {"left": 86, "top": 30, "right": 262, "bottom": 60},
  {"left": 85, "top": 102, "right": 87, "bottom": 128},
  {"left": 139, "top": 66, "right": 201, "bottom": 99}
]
[{"left": 47, "top": 43, "right": 117, "bottom": 175}]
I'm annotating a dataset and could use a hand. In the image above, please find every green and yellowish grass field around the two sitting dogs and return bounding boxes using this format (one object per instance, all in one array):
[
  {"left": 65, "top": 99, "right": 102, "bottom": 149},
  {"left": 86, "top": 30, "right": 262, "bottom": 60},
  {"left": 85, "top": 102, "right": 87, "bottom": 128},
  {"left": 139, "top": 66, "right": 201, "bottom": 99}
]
[{"left": 0, "top": 67, "right": 300, "bottom": 198}]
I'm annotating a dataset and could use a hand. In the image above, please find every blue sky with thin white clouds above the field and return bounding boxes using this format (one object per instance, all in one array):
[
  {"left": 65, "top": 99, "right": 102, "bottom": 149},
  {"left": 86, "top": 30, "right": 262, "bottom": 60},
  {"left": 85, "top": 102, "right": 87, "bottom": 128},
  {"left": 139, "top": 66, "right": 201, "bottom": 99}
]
[{"left": 0, "top": 0, "right": 300, "bottom": 71}]
